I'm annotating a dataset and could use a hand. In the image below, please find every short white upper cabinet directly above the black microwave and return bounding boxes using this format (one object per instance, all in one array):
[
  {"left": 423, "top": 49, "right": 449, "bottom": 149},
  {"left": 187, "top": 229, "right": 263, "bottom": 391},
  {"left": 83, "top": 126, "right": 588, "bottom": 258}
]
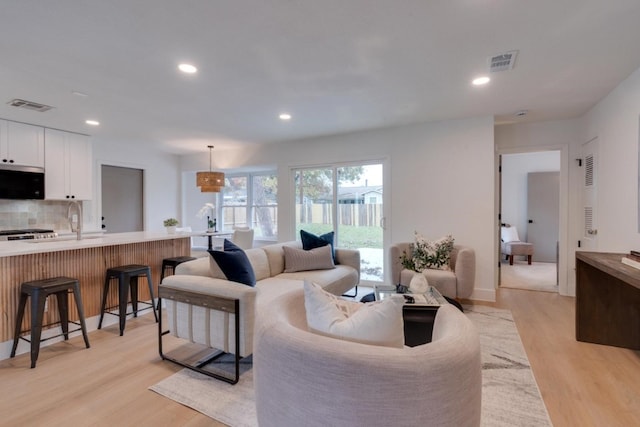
[{"left": 0, "top": 120, "right": 44, "bottom": 167}]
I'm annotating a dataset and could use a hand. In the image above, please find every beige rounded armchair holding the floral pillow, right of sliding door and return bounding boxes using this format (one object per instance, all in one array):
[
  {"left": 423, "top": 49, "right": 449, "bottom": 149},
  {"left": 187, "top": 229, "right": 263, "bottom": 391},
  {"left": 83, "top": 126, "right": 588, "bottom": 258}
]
[{"left": 389, "top": 242, "right": 476, "bottom": 299}]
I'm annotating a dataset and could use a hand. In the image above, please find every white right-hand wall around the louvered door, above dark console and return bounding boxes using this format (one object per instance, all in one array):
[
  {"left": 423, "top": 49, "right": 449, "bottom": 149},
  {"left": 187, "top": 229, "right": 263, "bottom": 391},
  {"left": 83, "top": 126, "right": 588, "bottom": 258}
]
[{"left": 496, "top": 63, "right": 640, "bottom": 295}]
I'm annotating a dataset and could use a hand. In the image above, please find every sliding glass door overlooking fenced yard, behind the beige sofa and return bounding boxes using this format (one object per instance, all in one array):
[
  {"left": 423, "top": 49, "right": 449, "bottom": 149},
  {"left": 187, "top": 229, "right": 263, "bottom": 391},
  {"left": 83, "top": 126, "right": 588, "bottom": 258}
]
[{"left": 293, "top": 163, "right": 384, "bottom": 282}]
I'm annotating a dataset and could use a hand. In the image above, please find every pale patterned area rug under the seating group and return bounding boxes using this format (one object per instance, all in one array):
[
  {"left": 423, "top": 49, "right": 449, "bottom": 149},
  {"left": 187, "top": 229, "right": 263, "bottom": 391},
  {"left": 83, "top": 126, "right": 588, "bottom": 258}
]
[{"left": 150, "top": 306, "right": 551, "bottom": 427}]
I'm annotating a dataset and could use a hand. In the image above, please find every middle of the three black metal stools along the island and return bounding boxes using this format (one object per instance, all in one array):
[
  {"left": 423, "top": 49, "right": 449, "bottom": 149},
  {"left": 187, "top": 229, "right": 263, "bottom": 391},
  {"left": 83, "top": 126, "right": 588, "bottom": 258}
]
[{"left": 98, "top": 264, "right": 158, "bottom": 336}]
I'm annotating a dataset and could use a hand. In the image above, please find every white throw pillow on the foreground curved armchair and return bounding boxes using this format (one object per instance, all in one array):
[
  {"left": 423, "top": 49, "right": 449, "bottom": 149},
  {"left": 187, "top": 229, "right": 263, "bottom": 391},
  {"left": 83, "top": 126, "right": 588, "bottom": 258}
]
[{"left": 304, "top": 280, "right": 404, "bottom": 348}]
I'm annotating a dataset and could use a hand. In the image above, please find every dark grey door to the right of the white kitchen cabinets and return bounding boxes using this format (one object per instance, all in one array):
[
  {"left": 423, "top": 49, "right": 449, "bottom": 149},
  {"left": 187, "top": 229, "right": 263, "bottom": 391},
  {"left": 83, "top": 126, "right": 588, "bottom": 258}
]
[{"left": 102, "top": 165, "right": 144, "bottom": 233}]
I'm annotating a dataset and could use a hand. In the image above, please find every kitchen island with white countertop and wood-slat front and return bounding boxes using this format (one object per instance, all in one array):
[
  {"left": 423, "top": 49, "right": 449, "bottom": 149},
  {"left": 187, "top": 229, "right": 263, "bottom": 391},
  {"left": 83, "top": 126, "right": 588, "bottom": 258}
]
[{"left": 0, "top": 232, "right": 191, "bottom": 352}]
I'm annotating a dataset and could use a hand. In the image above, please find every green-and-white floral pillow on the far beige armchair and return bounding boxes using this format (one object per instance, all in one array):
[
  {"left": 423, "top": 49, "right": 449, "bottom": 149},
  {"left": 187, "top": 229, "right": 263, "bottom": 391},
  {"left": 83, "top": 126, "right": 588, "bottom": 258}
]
[{"left": 400, "top": 231, "right": 453, "bottom": 271}]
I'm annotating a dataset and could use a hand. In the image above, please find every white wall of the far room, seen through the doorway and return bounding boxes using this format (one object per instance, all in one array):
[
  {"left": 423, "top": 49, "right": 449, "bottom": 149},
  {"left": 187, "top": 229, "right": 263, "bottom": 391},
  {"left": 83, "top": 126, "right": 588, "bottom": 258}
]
[{"left": 501, "top": 151, "right": 560, "bottom": 242}]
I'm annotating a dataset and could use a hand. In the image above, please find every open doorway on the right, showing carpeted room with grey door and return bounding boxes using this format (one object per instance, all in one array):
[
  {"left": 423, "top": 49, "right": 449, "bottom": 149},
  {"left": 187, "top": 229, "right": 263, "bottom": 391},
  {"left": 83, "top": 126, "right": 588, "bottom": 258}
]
[{"left": 499, "top": 150, "right": 561, "bottom": 292}]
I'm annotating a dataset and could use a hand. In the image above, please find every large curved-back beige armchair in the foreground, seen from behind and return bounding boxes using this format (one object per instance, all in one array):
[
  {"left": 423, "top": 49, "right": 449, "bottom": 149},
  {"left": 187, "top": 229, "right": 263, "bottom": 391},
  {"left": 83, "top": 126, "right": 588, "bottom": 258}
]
[{"left": 253, "top": 290, "right": 482, "bottom": 427}]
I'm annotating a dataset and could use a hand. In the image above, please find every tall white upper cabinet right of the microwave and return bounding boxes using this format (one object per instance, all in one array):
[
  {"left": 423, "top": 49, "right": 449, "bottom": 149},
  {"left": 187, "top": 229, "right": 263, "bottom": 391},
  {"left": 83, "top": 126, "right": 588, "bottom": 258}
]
[{"left": 44, "top": 129, "right": 93, "bottom": 200}]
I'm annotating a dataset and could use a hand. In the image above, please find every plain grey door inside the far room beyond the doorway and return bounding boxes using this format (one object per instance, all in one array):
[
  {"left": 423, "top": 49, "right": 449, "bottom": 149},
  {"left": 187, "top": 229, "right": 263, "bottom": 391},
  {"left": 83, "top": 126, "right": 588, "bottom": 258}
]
[{"left": 521, "top": 172, "right": 560, "bottom": 263}]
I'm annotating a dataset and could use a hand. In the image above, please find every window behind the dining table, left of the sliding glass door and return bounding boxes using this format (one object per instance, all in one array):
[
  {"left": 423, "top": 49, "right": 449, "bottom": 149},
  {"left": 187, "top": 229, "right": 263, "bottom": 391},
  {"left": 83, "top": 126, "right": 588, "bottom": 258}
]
[{"left": 218, "top": 172, "right": 278, "bottom": 240}]
